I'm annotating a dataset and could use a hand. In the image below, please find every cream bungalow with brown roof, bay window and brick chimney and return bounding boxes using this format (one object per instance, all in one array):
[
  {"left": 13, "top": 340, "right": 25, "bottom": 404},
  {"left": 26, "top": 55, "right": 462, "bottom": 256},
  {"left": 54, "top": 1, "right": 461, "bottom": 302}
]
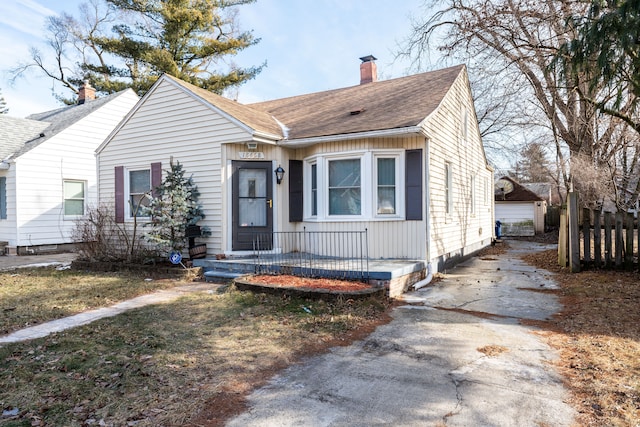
[{"left": 97, "top": 56, "right": 494, "bottom": 290}]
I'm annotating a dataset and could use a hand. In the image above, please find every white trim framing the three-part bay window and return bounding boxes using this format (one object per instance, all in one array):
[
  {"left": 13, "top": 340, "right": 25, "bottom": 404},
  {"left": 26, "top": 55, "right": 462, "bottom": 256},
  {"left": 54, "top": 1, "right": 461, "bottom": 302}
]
[{"left": 303, "top": 149, "right": 405, "bottom": 222}]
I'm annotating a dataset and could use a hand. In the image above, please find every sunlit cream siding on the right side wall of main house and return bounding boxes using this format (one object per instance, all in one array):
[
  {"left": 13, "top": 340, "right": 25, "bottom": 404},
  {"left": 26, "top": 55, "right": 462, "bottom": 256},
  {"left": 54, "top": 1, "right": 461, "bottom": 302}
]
[{"left": 424, "top": 68, "right": 494, "bottom": 268}]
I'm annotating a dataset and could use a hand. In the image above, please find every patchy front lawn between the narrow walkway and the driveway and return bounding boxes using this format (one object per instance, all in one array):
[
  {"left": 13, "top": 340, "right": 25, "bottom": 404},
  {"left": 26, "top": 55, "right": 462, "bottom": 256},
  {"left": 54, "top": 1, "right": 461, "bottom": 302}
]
[{"left": 0, "top": 288, "right": 389, "bottom": 427}]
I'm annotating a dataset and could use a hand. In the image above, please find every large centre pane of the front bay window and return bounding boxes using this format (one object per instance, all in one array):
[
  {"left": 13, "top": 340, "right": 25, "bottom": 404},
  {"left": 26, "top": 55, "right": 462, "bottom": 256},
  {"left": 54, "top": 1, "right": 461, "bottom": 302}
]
[{"left": 329, "top": 159, "right": 362, "bottom": 215}]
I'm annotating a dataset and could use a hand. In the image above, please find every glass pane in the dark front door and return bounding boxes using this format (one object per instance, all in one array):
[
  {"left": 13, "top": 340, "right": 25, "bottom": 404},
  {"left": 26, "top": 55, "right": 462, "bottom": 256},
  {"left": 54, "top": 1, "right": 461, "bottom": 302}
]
[{"left": 238, "top": 169, "right": 267, "bottom": 227}]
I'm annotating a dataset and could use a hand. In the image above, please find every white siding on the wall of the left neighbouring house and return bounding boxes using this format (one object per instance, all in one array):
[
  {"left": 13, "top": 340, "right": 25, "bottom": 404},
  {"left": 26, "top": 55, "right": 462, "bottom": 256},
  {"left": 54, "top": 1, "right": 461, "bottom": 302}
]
[{"left": 11, "top": 91, "right": 138, "bottom": 246}]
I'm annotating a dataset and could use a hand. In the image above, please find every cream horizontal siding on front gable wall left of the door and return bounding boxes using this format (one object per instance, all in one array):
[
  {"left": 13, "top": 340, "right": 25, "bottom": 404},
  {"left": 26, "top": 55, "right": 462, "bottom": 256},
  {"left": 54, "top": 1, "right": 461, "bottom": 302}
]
[{"left": 98, "top": 80, "right": 251, "bottom": 254}]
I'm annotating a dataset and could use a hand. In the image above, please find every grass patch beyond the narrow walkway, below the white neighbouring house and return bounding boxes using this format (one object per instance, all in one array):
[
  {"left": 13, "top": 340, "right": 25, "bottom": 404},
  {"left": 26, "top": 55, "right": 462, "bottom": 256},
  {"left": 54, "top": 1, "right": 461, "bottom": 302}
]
[{"left": 0, "top": 268, "right": 194, "bottom": 335}]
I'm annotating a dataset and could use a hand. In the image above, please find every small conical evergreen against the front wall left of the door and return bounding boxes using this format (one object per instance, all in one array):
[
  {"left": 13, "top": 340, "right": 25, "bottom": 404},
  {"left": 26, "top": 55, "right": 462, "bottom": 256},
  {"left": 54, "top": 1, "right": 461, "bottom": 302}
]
[{"left": 145, "top": 159, "right": 204, "bottom": 254}]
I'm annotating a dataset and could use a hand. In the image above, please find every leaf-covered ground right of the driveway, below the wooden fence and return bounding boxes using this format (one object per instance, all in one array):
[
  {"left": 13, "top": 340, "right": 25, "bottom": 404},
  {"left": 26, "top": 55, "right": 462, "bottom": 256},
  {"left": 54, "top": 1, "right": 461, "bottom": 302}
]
[{"left": 525, "top": 250, "right": 640, "bottom": 426}]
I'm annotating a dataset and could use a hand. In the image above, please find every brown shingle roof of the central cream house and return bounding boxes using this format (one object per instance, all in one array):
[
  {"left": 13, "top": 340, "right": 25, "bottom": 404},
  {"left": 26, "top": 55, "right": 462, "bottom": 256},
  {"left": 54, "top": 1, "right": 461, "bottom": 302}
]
[{"left": 167, "top": 65, "right": 464, "bottom": 139}]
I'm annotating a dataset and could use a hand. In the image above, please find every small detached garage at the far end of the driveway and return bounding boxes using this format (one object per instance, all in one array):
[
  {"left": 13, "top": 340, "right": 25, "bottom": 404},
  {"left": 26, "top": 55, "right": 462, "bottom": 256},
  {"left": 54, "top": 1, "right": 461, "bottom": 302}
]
[{"left": 494, "top": 176, "right": 547, "bottom": 236}]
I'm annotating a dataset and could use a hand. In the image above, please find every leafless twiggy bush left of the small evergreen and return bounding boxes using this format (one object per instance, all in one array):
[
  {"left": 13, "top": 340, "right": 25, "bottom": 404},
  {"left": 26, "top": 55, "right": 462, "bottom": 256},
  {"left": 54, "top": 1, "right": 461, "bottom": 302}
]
[{"left": 73, "top": 205, "right": 155, "bottom": 262}]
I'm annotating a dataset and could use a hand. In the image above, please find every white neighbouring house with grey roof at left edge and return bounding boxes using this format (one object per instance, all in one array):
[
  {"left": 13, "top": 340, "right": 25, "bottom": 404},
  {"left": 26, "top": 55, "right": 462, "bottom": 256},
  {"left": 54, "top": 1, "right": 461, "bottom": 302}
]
[{"left": 0, "top": 84, "right": 139, "bottom": 255}]
